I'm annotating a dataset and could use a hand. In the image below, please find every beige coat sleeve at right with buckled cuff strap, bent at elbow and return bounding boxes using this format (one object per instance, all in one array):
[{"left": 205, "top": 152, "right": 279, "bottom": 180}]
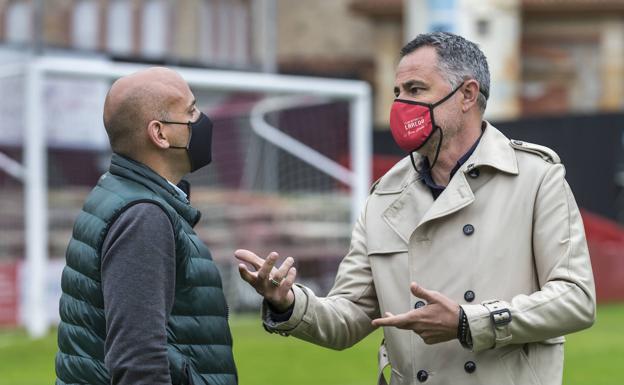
[{"left": 462, "top": 164, "right": 596, "bottom": 351}]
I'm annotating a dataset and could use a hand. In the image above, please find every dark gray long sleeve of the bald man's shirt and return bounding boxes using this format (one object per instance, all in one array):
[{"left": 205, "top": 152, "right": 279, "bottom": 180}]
[{"left": 102, "top": 203, "right": 175, "bottom": 385}]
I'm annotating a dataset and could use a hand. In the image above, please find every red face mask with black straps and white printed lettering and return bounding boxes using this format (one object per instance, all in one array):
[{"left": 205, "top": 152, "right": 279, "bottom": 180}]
[{"left": 390, "top": 83, "right": 463, "bottom": 153}]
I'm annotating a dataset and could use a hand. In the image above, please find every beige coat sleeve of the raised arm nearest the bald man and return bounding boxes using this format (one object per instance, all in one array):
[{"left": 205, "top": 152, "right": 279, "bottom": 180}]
[{"left": 262, "top": 202, "right": 379, "bottom": 350}]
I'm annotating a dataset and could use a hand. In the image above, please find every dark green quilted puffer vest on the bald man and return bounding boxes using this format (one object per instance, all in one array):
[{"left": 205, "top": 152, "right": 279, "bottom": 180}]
[{"left": 56, "top": 154, "right": 237, "bottom": 385}]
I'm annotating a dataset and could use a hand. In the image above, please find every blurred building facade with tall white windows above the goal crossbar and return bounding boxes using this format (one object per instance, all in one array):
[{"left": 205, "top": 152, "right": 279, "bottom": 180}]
[{"left": 0, "top": 0, "right": 274, "bottom": 70}]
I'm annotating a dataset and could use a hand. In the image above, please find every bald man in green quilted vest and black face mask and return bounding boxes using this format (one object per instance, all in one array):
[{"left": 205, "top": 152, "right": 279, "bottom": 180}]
[{"left": 56, "top": 68, "right": 238, "bottom": 385}]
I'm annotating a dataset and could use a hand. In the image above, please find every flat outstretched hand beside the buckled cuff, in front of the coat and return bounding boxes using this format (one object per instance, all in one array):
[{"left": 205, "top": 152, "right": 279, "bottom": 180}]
[{"left": 373, "top": 282, "right": 459, "bottom": 345}]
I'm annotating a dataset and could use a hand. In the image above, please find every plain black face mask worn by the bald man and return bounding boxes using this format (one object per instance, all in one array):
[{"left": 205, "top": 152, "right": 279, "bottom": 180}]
[{"left": 160, "top": 112, "right": 212, "bottom": 172}]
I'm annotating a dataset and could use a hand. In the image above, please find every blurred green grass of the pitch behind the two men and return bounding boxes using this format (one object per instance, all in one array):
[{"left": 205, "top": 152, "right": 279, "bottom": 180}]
[{"left": 0, "top": 304, "right": 624, "bottom": 385}]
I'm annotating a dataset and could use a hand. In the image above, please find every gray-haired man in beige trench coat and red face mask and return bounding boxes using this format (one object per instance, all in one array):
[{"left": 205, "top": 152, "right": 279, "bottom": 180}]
[{"left": 236, "top": 32, "right": 595, "bottom": 385}]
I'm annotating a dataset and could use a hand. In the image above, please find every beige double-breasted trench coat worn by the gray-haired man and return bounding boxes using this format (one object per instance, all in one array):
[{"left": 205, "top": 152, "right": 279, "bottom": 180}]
[{"left": 263, "top": 125, "right": 595, "bottom": 385}]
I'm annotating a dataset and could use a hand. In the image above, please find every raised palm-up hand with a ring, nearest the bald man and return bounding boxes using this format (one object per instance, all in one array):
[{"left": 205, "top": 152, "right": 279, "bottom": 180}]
[{"left": 234, "top": 249, "right": 297, "bottom": 311}]
